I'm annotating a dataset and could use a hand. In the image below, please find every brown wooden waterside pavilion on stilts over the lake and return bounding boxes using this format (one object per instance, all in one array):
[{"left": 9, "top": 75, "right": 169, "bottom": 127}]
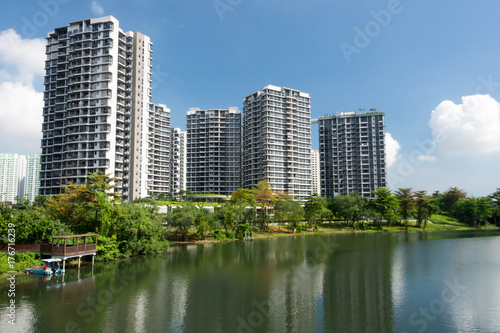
[{"left": 40, "top": 234, "right": 97, "bottom": 271}]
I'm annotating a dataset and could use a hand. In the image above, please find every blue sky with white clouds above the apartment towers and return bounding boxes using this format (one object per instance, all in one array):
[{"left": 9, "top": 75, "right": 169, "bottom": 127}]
[{"left": 0, "top": 0, "right": 500, "bottom": 195}]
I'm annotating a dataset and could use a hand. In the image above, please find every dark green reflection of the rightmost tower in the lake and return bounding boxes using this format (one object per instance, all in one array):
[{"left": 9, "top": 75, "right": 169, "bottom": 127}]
[{"left": 323, "top": 235, "right": 393, "bottom": 332}]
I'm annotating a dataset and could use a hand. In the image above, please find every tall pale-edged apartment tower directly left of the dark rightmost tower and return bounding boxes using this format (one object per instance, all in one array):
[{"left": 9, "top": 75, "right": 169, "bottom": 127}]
[{"left": 243, "top": 85, "right": 312, "bottom": 200}]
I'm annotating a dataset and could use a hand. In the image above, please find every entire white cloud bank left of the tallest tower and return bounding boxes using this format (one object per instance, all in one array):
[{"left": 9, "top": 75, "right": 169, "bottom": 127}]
[{"left": 0, "top": 29, "right": 45, "bottom": 154}]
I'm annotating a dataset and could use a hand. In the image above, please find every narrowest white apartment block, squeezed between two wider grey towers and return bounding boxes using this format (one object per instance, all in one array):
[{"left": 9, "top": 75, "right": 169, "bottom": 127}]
[{"left": 170, "top": 128, "right": 187, "bottom": 195}]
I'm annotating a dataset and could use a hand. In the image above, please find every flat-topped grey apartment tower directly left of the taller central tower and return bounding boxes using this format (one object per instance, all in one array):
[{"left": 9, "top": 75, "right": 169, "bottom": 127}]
[{"left": 187, "top": 108, "right": 241, "bottom": 195}]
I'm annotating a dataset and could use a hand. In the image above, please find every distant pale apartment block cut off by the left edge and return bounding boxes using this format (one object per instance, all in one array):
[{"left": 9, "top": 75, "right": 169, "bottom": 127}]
[{"left": 0, "top": 154, "right": 26, "bottom": 202}]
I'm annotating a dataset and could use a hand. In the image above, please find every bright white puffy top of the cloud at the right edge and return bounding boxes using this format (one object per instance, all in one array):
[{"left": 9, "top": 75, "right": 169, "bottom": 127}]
[{"left": 429, "top": 95, "right": 500, "bottom": 156}]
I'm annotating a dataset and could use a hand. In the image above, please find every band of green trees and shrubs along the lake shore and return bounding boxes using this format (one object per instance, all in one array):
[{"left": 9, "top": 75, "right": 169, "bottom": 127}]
[{"left": 0, "top": 172, "right": 500, "bottom": 275}]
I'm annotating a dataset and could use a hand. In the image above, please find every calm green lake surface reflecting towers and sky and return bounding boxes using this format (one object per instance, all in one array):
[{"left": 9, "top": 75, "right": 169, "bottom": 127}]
[{"left": 0, "top": 232, "right": 500, "bottom": 333}]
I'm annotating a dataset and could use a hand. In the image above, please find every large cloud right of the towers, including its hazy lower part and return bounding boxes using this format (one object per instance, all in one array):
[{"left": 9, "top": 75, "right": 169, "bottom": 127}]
[{"left": 386, "top": 95, "right": 500, "bottom": 195}]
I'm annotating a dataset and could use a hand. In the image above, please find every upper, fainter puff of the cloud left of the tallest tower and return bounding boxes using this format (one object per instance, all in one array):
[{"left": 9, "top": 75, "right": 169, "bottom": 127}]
[{"left": 0, "top": 29, "right": 45, "bottom": 85}]
